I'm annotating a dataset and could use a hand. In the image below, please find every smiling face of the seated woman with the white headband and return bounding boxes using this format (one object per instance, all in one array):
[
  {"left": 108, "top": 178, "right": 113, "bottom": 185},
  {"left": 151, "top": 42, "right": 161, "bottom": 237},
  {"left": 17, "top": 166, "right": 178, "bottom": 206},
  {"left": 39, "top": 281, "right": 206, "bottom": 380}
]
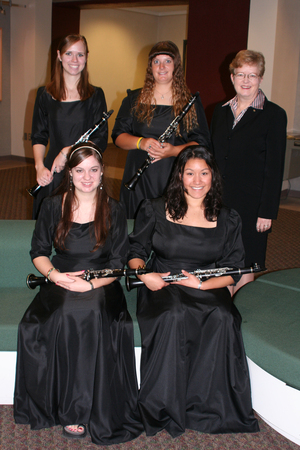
[{"left": 70, "top": 156, "right": 103, "bottom": 194}]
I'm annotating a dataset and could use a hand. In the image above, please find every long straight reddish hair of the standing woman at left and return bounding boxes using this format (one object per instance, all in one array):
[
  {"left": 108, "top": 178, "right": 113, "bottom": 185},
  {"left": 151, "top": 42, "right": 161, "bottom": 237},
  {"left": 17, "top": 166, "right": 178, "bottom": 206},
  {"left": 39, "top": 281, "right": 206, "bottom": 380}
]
[{"left": 46, "top": 34, "right": 94, "bottom": 101}]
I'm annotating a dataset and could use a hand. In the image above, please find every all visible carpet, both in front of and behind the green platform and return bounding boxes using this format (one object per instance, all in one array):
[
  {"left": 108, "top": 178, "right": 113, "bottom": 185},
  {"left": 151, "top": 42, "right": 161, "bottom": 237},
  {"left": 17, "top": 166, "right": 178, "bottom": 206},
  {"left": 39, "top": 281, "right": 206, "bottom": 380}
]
[{"left": 0, "top": 165, "right": 300, "bottom": 450}]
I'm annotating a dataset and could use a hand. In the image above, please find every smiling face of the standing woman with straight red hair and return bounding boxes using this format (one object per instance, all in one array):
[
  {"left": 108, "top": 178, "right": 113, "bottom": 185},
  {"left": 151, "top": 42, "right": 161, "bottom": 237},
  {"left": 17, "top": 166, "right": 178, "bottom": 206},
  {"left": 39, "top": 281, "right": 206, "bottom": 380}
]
[{"left": 57, "top": 41, "right": 87, "bottom": 76}]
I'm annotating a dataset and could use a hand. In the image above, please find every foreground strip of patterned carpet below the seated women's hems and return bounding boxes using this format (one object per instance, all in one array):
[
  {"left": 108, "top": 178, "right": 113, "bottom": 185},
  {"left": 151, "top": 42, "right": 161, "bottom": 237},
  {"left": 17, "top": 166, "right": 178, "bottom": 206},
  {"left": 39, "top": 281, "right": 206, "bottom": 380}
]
[{"left": 0, "top": 406, "right": 299, "bottom": 450}]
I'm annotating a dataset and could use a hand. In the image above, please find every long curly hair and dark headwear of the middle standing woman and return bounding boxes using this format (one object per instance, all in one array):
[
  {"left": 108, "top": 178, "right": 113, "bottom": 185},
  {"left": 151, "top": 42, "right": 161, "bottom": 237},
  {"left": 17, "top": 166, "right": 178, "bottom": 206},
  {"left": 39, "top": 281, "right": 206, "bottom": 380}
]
[{"left": 134, "top": 41, "right": 198, "bottom": 134}]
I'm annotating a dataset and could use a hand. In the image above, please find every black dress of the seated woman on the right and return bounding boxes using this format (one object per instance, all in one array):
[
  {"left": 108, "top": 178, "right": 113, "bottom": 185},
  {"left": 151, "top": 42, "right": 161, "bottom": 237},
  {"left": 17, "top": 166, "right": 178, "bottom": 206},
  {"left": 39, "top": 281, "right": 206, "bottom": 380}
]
[{"left": 129, "top": 199, "right": 259, "bottom": 437}]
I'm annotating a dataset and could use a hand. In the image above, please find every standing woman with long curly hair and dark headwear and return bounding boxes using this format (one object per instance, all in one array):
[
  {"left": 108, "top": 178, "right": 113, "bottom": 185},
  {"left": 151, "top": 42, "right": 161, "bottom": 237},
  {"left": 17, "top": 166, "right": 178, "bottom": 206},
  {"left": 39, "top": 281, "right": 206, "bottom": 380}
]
[{"left": 112, "top": 41, "right": 210, "bottom": 219}]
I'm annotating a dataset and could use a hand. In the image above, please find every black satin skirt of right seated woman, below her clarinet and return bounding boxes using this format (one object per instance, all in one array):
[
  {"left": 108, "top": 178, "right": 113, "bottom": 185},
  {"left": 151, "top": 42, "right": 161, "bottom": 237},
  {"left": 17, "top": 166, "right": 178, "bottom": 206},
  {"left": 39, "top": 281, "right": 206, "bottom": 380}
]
[{"left": 137, "top": 285, "right": 259, "bottom": 437}]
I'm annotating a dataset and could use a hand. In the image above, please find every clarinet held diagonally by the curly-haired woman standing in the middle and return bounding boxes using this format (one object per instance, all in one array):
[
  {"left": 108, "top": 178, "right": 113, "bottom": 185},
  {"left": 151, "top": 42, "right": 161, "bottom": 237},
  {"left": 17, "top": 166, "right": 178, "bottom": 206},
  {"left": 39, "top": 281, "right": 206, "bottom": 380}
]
[{"left": 124, "top": 92, "right": 199, "bottom": 191}]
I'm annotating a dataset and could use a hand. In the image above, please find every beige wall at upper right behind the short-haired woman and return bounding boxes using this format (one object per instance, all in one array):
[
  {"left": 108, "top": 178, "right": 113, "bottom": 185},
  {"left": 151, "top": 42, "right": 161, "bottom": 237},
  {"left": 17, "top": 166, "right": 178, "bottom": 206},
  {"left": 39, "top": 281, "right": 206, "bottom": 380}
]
[{"left": 248, "top": 0, "right": 300, "bottom": 133}]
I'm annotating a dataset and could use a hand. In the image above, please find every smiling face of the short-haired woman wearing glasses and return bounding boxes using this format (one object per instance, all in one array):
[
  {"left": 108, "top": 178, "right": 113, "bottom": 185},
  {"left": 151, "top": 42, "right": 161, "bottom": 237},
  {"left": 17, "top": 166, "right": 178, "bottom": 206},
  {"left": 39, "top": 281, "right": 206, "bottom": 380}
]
[{"left": 230, "top": 64, "right": 262, "bottom": 103}]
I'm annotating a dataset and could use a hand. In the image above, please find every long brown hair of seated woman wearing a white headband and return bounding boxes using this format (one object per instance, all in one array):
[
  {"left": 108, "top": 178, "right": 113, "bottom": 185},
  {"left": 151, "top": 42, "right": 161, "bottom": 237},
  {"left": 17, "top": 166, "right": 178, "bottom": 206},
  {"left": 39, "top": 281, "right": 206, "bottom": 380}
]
[{"left": 54, "top": 141, "right": 111, "bottom": 251}]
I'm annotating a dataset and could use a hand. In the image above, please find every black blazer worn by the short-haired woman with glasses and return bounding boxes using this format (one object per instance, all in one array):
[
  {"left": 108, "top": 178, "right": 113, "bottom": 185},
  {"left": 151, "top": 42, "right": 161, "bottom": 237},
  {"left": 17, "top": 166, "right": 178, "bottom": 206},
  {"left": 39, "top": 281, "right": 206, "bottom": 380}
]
[{"left": 211, "top": 99, "right": 287, "bottom": 221}]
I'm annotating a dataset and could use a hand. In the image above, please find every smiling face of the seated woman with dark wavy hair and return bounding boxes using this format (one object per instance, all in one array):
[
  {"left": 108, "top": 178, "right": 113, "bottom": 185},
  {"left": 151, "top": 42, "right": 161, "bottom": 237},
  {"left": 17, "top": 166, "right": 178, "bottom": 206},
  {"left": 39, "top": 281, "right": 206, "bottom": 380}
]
[{"left": 182, "top": 158, "right": 212, "bottom": 200}]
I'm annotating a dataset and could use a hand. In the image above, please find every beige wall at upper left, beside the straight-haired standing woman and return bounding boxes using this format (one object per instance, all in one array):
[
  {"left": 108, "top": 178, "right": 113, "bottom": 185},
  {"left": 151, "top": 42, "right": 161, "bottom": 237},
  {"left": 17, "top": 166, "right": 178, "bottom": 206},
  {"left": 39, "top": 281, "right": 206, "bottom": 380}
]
[{"left": 10, "top": 0, "right": 52, "bottom": 157}]
